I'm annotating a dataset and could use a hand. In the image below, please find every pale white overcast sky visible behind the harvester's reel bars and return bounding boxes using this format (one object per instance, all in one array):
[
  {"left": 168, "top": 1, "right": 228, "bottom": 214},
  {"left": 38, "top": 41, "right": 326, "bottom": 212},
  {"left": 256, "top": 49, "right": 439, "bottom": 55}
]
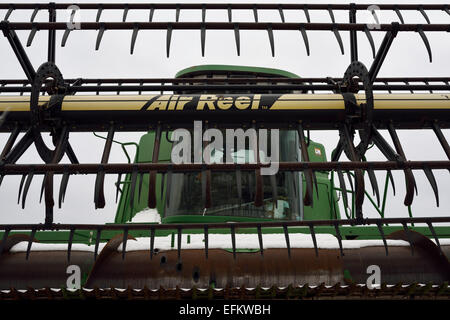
[{"left": 0, "top": 0, "right": 450, "bottom": 223}]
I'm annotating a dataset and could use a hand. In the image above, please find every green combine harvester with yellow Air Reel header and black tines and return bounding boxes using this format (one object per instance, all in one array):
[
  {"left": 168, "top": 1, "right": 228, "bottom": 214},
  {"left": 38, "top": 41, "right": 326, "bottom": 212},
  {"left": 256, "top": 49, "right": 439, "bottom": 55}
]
[{"left": 0, "top": 3, "right": 450, "bottom": 299}]
